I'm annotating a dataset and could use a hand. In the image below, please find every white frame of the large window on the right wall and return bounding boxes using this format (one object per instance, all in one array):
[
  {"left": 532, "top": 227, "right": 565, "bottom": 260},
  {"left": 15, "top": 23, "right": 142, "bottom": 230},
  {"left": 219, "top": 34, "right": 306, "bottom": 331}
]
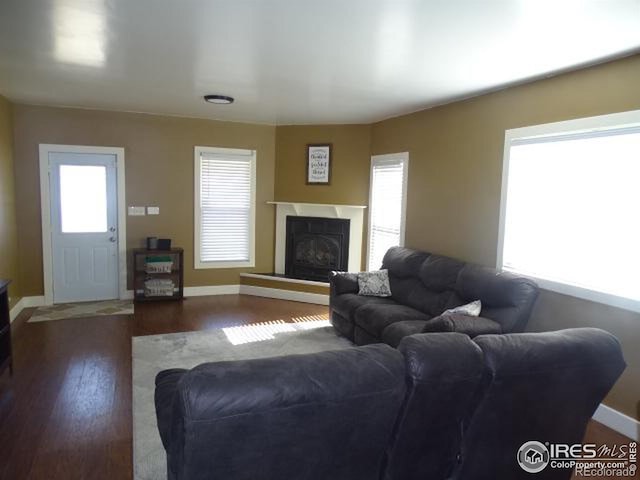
[{"left": 496, "top": 110, "right": 640, "bottom": 312}]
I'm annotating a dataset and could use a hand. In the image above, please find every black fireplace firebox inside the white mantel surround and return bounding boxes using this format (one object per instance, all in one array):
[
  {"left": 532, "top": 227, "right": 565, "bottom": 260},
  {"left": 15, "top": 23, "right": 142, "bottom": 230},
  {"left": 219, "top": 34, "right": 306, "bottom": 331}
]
[{"left": 285, "top": 216, "right": 351, "bottom": 282}]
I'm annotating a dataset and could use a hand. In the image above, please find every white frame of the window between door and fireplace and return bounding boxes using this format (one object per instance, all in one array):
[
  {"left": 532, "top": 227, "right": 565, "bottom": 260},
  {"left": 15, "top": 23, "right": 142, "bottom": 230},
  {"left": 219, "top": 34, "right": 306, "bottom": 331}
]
[{"left": 193, "top": 146, "right": 257, "bottom": 270}]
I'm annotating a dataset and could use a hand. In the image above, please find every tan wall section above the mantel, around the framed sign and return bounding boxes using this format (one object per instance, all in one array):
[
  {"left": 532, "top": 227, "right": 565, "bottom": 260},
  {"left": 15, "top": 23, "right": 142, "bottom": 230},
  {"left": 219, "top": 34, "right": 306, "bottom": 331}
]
[{"left": 275, "top": 125, "right": 371, "bottom": 267}]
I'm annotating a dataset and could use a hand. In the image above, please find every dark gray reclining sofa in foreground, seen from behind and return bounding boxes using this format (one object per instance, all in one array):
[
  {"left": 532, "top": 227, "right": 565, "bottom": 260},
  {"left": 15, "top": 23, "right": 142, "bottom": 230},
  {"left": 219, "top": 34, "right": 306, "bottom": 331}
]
[{"left": 155, "top": 328, "right": 625, "bottom": 480}]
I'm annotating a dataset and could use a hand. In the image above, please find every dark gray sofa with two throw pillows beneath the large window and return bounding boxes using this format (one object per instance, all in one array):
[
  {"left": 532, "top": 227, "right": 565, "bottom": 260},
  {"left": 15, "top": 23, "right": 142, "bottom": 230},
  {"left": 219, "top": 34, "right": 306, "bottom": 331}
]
[{"left": 329, "top": 247, "right": 538, "bottom": 347}]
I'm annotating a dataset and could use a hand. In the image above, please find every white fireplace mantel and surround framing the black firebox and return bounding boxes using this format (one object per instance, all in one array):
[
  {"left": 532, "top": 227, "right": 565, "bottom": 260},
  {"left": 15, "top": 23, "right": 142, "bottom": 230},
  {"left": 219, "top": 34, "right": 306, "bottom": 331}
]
[{"left": 267, "top": 202, "right": 367, "bottom": 274}]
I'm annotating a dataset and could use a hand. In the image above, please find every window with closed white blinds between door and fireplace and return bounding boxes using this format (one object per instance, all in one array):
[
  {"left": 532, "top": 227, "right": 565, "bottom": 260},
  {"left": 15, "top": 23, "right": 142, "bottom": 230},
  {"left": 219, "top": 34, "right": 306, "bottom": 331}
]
[{"left": 195, "top": 147, "right": 256, "bottom": 268}]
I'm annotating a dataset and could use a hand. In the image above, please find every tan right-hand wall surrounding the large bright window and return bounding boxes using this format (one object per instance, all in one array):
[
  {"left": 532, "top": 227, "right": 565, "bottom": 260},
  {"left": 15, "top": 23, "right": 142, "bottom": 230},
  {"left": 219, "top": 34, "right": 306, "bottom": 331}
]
[{"left": 370, "top": 55, "right": 640, "bottom": 418}]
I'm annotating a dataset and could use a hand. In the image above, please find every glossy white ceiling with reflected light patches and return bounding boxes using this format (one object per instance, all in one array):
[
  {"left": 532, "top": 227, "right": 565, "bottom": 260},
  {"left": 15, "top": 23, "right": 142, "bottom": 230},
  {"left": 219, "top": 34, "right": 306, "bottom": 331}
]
[{"left": 0, "top": 0, "right": 640, "bottom": 124}]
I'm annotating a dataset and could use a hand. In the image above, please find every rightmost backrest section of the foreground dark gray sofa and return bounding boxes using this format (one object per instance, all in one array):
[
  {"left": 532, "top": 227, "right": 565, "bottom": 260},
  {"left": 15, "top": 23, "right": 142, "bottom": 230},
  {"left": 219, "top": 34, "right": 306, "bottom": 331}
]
[{"left": 452, "top": 328, "right": 625, "bottom": 480}]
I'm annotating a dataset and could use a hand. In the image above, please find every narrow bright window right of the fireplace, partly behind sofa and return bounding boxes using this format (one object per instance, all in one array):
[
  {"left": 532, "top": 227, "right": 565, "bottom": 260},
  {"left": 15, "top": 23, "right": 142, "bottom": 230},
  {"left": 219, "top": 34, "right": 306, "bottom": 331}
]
[{"left": 367, "top": 153, "right": 409, "bottom": 270}]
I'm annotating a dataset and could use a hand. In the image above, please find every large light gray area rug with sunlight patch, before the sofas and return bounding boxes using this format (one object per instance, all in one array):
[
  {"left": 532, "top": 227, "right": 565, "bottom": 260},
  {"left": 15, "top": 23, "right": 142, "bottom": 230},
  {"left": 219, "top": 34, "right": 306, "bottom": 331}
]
[{"left": 132, "top": 317, "right": 353, "bottom": 480}]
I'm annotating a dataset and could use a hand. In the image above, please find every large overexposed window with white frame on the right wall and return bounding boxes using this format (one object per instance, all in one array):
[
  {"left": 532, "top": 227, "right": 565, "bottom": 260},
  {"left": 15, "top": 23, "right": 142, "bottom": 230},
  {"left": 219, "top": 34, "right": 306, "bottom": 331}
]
[{"left": 498, "top": 111, "right": 640, "bottom": 311}]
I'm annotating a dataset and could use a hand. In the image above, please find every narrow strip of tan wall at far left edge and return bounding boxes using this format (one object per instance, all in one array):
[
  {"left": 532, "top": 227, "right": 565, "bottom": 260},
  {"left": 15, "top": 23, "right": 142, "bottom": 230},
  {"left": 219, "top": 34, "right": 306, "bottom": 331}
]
[{"left": 0, "top": 96, "right": 21, "bottom": 307}]
